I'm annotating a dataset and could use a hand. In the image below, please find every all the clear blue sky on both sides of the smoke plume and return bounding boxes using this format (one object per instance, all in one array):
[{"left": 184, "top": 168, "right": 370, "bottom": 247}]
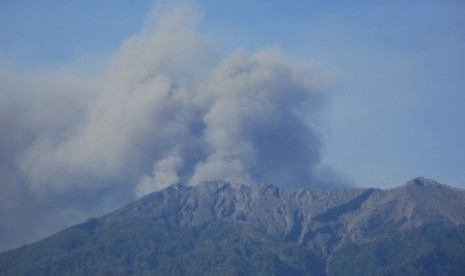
[{"left": 0, "top": 0, "right": 465, "bottom": 190}]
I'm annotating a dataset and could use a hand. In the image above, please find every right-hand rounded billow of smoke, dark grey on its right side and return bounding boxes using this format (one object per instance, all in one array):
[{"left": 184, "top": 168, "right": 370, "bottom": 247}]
[{"left": 138, "top": 47, "right": 322, "bottom": 194}]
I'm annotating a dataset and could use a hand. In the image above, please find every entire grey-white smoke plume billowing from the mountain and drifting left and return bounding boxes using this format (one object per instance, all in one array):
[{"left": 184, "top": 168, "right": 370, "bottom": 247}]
[{"left": 0, "top": 6, "right": 340, "bottom": 250}]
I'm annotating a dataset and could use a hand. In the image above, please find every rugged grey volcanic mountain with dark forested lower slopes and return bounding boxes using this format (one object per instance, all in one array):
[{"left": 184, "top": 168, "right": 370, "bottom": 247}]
[{"left": 0, "top": 178, "right": 465, "bottom": 275}]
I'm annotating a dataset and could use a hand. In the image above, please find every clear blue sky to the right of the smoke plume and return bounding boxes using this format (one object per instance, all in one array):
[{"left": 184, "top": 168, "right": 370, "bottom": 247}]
[{"left": 203, "top": 1, "right": 465, "bottom": 187}]
